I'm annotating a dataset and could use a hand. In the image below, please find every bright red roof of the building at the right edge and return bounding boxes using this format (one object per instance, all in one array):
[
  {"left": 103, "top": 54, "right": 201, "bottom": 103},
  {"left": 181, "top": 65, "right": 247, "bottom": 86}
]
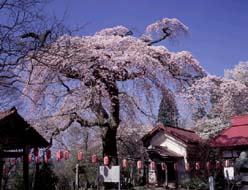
[{"left": 210, "top": 115, "right": 248, "bottom": 147}]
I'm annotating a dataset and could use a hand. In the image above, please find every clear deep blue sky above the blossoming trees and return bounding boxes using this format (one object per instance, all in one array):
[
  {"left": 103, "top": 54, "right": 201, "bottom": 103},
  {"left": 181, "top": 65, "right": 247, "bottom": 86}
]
[{"left": 47, "top": 0, "right": 248, "bottom": 76}]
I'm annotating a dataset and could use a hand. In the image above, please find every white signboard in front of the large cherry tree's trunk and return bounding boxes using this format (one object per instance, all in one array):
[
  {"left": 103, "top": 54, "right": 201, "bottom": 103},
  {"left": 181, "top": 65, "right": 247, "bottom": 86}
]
[{"left": 99, "top": 166, "right": 120, "bottom": 183}]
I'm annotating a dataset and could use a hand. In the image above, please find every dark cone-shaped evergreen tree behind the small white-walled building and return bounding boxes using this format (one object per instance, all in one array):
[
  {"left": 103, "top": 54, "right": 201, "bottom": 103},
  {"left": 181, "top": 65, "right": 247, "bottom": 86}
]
[{"left": 158, "top": 90, "right": 179, "bottom": 127}]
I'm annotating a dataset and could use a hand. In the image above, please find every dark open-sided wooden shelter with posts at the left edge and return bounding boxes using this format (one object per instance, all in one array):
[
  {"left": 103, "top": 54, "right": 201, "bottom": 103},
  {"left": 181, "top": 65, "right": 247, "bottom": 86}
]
[{"left": 0, "top": 108, "right": 50, "bottom": 190}]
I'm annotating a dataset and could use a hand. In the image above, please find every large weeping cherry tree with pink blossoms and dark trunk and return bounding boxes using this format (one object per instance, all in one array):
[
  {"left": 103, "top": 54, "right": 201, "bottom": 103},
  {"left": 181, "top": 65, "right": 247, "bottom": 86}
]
[{"left": 22, "top": 18, "right": 205, "bottom": 163}]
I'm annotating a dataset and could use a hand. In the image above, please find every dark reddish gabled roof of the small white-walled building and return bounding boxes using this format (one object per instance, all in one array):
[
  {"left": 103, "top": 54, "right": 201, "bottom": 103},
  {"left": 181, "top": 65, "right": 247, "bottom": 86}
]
[{"left": 142, "top": 124, "right": 203, "bottom": 144}]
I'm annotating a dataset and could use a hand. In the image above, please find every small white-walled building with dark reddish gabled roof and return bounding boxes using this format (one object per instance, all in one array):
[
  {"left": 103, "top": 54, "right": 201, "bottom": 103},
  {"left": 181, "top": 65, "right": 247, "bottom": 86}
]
[{"left": 142, "top": 124, "right": 203, "bottom": 186}]
